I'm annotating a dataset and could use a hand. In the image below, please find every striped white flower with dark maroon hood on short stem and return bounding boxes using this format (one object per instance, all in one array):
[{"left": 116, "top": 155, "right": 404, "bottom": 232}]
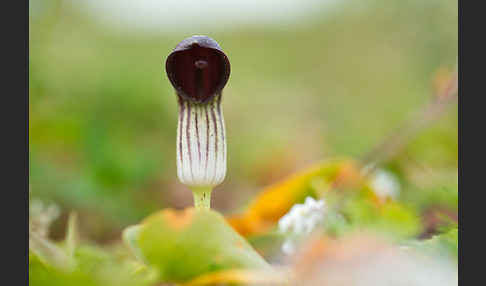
[{"left": 165, "top": 36, "right": 230, "bottom": 208}]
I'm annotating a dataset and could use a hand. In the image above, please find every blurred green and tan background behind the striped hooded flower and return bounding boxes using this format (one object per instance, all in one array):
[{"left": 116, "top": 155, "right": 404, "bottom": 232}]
[{"left": 29, "top": 0, "right": 458, "bottom": 241}]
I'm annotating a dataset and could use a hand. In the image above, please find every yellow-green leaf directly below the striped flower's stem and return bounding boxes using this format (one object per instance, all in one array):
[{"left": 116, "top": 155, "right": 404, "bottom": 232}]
[{"left": 124, "top": 209, "right": 269, "bottom": 281}]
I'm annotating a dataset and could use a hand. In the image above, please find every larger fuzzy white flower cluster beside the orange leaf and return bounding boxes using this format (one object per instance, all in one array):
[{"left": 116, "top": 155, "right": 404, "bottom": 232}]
[{"left": 278, "top": 197, "right": 325, "bottom": 254}]
